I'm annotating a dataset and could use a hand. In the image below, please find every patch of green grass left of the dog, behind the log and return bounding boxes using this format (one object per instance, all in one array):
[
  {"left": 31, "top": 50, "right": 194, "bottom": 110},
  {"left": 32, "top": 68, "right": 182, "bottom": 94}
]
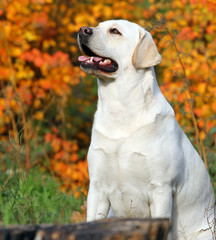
[{"left": 0, "top": 168, "right": 83, "bottom": 225}]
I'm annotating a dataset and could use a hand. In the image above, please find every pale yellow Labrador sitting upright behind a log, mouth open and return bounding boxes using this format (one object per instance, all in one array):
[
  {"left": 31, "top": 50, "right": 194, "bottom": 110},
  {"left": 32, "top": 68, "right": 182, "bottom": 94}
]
[{"left": 78, "top": 20, "right": 214, "bottom": 240}]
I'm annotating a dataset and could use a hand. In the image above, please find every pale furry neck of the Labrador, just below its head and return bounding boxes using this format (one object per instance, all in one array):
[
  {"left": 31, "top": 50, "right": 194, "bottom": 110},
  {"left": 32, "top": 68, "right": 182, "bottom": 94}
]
[{"left": 98, "top": 67, "right": 173, "bottom": 114}]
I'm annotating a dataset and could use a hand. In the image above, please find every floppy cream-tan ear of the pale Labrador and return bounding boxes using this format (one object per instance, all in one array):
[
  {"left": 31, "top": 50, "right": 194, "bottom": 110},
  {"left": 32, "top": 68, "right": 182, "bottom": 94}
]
[{"left": 132, "top": 29, "right": 161, "bottom": 69}]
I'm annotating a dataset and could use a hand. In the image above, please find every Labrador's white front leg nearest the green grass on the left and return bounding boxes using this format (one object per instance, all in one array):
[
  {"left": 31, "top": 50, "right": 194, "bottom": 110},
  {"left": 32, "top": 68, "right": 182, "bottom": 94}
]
[{"left": 87, "top": 181, "right": 110, "bottom": 222}]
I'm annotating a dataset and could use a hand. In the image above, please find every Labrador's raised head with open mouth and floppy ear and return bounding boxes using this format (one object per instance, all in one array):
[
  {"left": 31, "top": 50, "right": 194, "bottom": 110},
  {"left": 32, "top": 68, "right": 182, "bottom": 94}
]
[{"left": 78, "top": 20, "right": 161, "bottom": 78}]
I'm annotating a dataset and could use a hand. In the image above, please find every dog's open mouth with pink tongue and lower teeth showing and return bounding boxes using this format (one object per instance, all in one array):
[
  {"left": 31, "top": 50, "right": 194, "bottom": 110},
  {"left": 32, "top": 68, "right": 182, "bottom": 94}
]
[{"left": 78, "top": 43, "right": 118, "bottom": 73}]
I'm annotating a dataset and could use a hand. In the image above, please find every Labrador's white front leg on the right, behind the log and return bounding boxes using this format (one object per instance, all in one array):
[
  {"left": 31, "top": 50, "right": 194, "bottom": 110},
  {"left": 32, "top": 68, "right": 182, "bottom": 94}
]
[{"left": 150, "top": 184, "right": 173, "bottom": 219}]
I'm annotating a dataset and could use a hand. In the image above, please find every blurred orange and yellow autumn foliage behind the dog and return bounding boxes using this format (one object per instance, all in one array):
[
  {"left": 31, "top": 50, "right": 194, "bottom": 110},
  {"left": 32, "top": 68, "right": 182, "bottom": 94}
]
[{"left": 0, "top": 0, "right": 216, "bottom": 197}]
